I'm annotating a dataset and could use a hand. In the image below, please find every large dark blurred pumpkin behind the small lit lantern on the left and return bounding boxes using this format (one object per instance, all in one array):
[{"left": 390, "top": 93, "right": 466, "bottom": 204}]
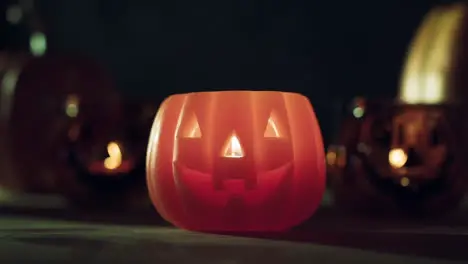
[{"left": 3, "top": 56, "right": 126, "bottom": 196}]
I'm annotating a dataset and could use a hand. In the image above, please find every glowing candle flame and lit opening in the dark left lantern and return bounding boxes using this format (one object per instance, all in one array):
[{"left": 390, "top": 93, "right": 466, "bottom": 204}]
[{"left": 89, "top": 142, "right": 132, "bottom": 174}]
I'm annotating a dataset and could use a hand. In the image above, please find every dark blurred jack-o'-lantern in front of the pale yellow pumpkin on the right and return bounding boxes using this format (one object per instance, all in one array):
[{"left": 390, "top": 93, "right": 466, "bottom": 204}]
[{"left": 329, "top": 101, "right": 465, "bottom": 212}]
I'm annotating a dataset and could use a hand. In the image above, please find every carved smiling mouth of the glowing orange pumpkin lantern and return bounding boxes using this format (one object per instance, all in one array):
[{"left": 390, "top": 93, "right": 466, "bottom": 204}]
[{"left": 174, "top": 162, "right": 292, "bottom": 206}]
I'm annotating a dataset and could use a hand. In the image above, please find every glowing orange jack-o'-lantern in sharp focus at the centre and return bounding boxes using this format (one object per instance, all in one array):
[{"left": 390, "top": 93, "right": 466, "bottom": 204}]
[{"left": 147, "top": 91, "right": 325, "bottom": 230}]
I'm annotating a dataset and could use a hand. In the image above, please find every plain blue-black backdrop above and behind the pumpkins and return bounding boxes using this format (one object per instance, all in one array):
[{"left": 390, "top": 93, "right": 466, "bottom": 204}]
[{"left": 1, "top": 0, "right": 454, "bottom": 141}]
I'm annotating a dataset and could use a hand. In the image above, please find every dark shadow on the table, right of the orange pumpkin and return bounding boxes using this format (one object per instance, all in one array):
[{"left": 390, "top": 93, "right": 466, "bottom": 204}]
[{"left": 217, "top": 208, "right": 468, "bottom": 261}]
